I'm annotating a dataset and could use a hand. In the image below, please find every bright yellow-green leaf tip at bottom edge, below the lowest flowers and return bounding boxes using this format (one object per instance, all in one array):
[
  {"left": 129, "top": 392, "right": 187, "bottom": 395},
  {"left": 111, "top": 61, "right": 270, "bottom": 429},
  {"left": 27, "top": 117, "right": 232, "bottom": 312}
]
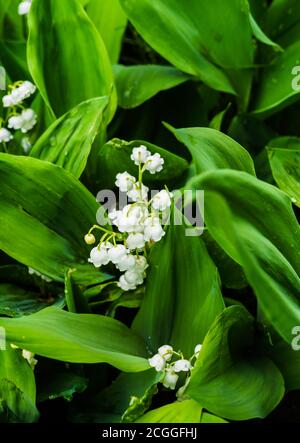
[{"left": 136, "top": 400, "right": 202, "bottom": 423}]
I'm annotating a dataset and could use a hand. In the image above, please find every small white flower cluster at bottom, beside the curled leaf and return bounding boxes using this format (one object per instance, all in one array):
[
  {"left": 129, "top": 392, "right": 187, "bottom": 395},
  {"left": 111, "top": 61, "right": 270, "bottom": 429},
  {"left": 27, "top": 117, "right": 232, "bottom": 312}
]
[{"left": 148, "top": 344, "right": 202, "bottom": 389}]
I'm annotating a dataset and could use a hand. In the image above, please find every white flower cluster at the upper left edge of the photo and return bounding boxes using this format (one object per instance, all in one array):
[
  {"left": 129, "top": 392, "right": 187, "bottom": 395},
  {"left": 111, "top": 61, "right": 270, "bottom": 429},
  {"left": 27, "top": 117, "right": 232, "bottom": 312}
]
[{"left": 0, "top": 81, "right": 37, "bottom": 147}]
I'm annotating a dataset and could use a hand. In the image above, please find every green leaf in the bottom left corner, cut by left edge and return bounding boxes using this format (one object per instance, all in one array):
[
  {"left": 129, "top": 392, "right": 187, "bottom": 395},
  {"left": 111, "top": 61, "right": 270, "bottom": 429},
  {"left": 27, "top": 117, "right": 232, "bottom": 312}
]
[{"left": 0, "top": 348, "right": 39, "bottom": 423}]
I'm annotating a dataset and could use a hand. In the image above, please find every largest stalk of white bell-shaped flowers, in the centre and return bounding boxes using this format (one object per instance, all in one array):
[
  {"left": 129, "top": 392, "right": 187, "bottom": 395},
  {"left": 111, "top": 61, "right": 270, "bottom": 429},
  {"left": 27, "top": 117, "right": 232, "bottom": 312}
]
[{"left": 85, "top": 145, "right": 172, "bottom": 291}]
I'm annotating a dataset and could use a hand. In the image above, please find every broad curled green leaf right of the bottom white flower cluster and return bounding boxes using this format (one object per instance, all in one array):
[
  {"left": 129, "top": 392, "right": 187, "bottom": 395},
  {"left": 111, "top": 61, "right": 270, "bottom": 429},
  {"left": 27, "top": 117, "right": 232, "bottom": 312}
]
[{"left": 185, "top": 306, "right": 284, "bottom": 420}]
